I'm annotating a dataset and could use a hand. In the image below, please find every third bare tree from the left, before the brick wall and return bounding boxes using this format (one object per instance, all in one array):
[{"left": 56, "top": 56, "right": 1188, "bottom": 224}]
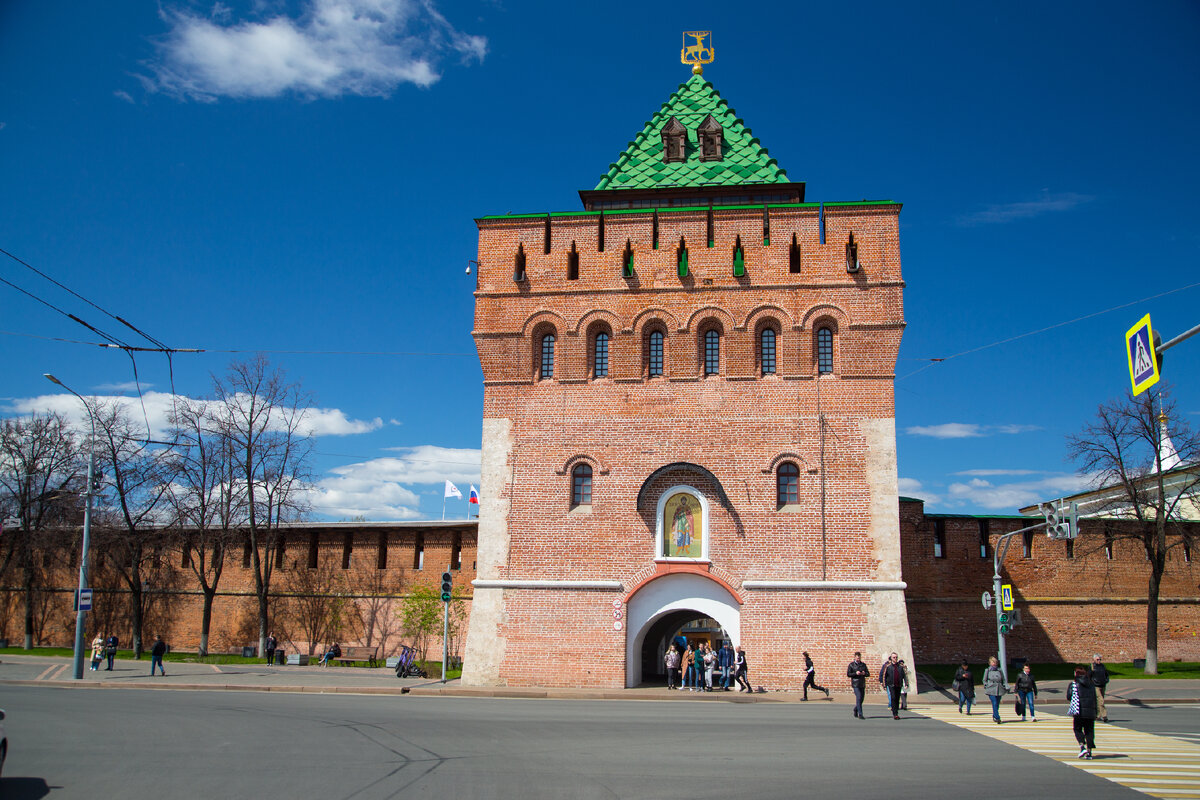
[{"left": 166, "top": 398, "right": 246, "bottom": 656}]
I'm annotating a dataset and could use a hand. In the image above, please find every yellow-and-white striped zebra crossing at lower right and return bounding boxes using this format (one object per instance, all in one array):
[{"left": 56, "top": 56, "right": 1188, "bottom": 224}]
[{"left": 911, "top": 702, "right": 1200, "bottom": 799}]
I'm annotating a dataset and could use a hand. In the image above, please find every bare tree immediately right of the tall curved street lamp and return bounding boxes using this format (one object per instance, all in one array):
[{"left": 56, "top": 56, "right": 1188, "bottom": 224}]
[{"left": 91, "top": 401, "right": 173, "bottom": 658}]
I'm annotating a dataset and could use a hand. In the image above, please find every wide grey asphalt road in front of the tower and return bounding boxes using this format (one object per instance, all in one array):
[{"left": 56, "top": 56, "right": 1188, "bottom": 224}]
[{"left": 0, "top": 686, "right": 1200, "bottom": 800}]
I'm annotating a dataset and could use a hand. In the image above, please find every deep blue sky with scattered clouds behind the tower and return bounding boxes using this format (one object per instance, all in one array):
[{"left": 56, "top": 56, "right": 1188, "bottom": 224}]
[{"left": 0, "top": 0, "right": 1200, "bottom": 519}]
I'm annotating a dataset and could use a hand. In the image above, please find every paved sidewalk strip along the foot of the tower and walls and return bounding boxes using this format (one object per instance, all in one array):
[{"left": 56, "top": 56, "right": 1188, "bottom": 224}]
[{"left": 0, "top": 655, "right": 1200, "bottom": 705}]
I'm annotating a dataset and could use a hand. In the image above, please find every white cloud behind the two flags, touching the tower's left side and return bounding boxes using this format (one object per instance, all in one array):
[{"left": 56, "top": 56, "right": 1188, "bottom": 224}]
[{"left": 307, "top": 445, "right": 481, "bottom": 519}]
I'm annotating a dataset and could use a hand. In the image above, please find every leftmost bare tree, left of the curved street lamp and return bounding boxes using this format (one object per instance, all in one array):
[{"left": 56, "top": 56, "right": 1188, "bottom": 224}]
[{"left": 0, "top": 414, "right": 82, "bottom": 650}]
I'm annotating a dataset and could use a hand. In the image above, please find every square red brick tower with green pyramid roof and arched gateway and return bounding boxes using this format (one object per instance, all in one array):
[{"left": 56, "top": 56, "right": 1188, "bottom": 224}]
[{"left": 463, "top": 67, "right": 913, "bottom": 688}]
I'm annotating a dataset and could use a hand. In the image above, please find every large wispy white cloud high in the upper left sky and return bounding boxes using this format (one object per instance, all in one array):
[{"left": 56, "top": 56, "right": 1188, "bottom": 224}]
[{"left": 143, "top": 0, "right": 487, "bottom": 101}]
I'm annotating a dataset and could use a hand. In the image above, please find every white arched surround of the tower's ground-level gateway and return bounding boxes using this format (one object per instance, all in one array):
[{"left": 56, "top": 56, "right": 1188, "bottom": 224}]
[{"left": 625, "top": 572, "right": 742, "bottom": 688}]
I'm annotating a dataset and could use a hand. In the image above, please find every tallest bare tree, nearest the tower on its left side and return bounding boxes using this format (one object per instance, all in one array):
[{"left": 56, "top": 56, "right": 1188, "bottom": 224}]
[{"left": 214, "top": 355, "right": 312, "bottom": 652}]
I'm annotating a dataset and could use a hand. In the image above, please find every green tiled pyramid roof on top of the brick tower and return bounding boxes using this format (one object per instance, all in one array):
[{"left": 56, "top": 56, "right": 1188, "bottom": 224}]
[{"left": 596, "top": 76, "right": 788, "bottom": 190}]
